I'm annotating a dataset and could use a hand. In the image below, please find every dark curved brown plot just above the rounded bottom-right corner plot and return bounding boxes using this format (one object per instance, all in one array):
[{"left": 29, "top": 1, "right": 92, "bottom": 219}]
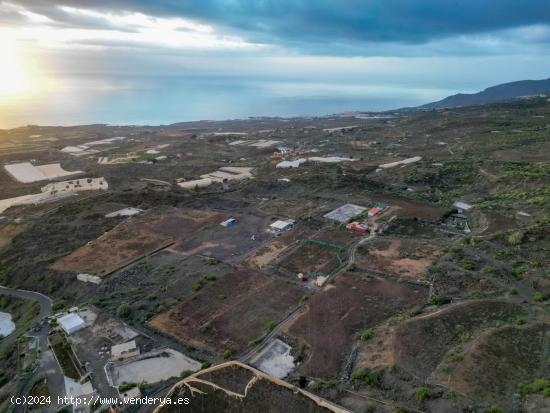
[{"left": 393, "top": 301, "right": 521, "bottom": 378}]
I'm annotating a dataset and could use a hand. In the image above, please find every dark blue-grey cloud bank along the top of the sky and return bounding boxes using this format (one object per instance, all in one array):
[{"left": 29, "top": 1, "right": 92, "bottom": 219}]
[{"left": 9, "top": 0, "right": 550, "bottom": 46}]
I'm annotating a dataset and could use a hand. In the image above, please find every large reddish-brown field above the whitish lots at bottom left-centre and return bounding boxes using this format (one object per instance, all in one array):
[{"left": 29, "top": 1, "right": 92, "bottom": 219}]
[{"left": 150, "top": 269, "right": 304, "bottom": 354}]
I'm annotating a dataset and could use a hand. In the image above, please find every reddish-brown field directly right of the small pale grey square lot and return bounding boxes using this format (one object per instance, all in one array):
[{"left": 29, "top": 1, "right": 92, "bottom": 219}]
[{"left": 286, "top": 273, "right": 428, "bottom": 378}]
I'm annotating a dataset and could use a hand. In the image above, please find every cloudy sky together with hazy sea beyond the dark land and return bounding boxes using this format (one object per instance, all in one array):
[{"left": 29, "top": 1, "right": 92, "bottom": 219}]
[{"left": 0, "top": 0, "right": 550, "bottom": 128}]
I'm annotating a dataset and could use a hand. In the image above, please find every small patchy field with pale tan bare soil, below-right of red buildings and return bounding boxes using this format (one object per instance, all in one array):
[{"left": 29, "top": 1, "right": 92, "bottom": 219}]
[{"left": 357, "top": 238, "right": 439, "bottom": 278}]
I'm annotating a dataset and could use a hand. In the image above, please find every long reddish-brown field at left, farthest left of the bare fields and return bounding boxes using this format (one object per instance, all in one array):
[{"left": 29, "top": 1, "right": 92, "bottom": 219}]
[{"left": 53, "top": 208, "right": 225, "bottom": 275}]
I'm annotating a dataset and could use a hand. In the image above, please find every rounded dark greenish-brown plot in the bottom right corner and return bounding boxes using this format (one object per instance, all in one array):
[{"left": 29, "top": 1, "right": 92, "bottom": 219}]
[{"left": 451, "top": 323, "right": 550, "bottom": 404}]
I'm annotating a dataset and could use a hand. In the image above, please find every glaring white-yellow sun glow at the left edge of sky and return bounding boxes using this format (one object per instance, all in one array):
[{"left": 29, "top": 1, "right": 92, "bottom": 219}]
[{"left": 0, "top": 33, "right": 32, "bottom": 97}]
